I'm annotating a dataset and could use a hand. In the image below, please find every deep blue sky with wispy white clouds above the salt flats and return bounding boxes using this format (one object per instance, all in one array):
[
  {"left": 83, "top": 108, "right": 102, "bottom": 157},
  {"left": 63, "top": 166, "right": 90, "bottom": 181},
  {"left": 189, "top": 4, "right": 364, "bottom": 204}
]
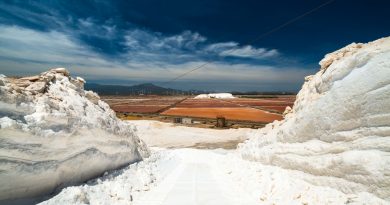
[{"left": 0, "top": 0, "right": 390, "bottom": 91}]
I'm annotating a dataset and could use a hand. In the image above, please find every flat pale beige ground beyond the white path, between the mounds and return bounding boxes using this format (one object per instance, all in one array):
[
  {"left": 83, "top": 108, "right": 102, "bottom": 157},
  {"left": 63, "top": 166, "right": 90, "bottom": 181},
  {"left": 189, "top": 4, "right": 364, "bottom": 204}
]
[{"left": 128, "top": 120, "right": 254, "bottom": 149}]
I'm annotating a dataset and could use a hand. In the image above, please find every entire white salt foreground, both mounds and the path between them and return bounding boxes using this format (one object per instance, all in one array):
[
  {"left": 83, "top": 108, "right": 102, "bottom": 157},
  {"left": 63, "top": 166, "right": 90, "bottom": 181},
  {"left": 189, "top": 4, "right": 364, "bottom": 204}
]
[{"left": 0, "top": 38, "right": 390, "bottom": 205}]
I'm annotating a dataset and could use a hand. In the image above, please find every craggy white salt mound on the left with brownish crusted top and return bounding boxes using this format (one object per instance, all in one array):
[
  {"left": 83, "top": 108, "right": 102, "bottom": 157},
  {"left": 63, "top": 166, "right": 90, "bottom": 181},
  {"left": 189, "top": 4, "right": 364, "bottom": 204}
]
[{"left": 0, "top": 68, "right": 149, "bottom": 203}]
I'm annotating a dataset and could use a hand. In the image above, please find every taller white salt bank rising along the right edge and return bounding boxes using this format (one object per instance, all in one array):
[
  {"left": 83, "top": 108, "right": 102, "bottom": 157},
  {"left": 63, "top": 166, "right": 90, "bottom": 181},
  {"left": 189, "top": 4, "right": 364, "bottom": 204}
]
[{"left": 239, "top": 37, "right": 390, "bottom": 204}]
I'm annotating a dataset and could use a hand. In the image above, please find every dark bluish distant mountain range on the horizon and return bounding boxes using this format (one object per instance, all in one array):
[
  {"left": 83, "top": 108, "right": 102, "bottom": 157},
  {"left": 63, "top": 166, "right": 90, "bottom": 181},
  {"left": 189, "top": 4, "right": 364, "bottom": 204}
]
[{"left": 84, "top": 83, "right": 204, "bottom": 95}]
